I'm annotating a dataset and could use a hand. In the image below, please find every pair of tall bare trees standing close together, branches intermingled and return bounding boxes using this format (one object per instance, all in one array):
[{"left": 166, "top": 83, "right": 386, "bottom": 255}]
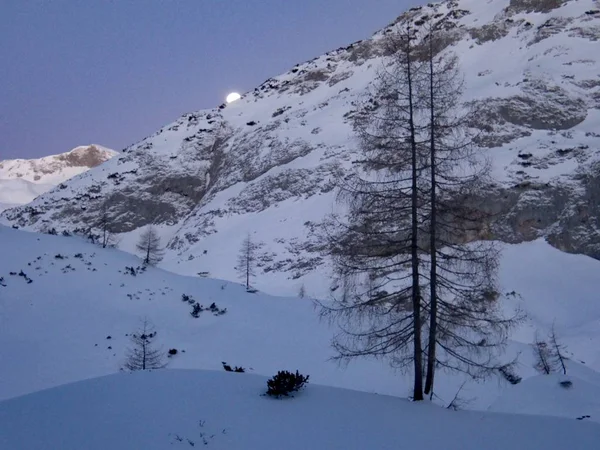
[{"left": 322, "top": 19, "right": 519, "bottom": 400}]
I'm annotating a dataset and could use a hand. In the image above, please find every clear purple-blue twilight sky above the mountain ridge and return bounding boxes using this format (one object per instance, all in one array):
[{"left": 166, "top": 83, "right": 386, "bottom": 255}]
[{"left": 0, "top": 0, "right": 425, "bottom": 160}]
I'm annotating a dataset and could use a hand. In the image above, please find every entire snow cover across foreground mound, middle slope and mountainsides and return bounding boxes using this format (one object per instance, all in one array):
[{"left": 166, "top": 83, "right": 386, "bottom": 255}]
[{"left": 0, "top": 0, "right": 600, "bottom": 442}]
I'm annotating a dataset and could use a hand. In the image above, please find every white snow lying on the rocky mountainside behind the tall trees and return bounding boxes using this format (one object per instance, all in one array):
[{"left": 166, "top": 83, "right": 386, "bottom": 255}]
[{"left": 0, "top": 0, "right": 600, "bottom": 297}]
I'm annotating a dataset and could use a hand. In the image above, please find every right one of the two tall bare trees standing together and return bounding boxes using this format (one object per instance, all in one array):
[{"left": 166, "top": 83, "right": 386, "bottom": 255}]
[{"left": 420, "top": 22, "right": 520, "bottom": 395}]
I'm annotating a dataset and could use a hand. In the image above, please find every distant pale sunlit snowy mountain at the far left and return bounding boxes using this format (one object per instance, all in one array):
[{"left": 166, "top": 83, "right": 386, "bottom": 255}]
[{"left": 0, "top": 144, "right": 118, "bottom": 210}]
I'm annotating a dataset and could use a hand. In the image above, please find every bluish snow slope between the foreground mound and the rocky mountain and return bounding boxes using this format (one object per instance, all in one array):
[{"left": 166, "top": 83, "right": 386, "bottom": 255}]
[{"left": 0, "top": 226, "right": 600, "bottom": 422}]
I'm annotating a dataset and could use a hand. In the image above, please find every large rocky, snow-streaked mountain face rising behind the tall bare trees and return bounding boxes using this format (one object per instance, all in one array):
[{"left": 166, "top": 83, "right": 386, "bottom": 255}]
[{"left": 0, "top": 0, "right": 600, "bottom": 292}]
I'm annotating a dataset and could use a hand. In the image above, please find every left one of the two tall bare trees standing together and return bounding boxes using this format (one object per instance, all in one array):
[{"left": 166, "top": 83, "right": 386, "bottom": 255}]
[{"left": 321, "top": 28, "right": 424, "bottom": 401}]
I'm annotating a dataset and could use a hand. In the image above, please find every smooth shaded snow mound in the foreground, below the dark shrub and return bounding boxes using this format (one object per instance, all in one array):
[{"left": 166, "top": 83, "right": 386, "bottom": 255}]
[{"left": 0, "top": 370, "right": 600, "bottom": 450}]
